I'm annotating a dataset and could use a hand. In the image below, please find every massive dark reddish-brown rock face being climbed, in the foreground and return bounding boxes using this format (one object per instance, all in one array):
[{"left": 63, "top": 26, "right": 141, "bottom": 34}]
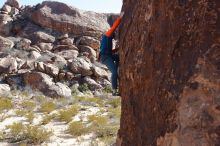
[{"left": 118, "top": 0, "right": 220, "bottom": 146}]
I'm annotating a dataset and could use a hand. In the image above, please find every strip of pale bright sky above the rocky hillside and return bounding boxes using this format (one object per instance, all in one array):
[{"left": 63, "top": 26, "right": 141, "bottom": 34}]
[{"left": 0, "top": 0, "right": 122, "bottom": 13}]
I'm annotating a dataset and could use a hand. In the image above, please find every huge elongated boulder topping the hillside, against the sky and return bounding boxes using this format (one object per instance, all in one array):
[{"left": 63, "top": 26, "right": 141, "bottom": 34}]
[{"left": 27, "top": 1, "right": 109, "bottom": 37}]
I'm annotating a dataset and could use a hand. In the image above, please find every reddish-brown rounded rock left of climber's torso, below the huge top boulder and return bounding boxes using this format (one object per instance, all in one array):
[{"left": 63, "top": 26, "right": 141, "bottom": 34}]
[{"left": 76, "top": 36, "right": 100, "bottom": 50}]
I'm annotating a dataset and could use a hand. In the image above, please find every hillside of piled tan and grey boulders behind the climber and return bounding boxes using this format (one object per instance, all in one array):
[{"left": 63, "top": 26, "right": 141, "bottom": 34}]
[{"left": 0, "top": 0, "right": 117, "bottom": 97}]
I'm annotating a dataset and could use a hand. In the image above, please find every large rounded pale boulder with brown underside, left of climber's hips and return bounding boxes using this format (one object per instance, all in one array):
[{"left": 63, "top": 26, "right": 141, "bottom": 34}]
[{"left": 69, "top": 57, "right": 93, "bottom": 76}]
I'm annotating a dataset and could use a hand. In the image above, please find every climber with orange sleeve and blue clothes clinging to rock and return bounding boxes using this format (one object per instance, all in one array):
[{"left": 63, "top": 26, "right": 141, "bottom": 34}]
[{"left": 99, "top": 12, "right": 124, "bottom": 96}]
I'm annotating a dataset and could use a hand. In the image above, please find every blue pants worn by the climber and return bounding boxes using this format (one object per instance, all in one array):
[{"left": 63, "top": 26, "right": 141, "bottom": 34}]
[{"left": 101, "top": 54, "right": 119, "bottom": 89}]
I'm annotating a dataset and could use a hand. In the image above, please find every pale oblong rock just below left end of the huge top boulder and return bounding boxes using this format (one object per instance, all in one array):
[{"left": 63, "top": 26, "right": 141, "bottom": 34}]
[{"left": 32, "top": 31, "right": 55, "bottom": 43}]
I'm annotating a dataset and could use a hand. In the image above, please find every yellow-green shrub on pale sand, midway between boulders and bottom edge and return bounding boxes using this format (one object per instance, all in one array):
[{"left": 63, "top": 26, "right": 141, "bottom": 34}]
[{"left": 58, "top": 106, "right": 80, "bottom": 123}]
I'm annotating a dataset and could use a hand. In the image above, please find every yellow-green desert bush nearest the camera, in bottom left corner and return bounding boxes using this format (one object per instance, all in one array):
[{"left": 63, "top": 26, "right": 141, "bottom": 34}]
[{"left": 7, "top": 123, "right": 52, "bottom": 144}]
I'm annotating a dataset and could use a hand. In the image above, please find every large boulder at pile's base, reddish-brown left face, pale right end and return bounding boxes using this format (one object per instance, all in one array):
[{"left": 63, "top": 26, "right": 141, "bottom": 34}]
[{"left": 23, "top": 72, "right": 71, "bottom": 98}]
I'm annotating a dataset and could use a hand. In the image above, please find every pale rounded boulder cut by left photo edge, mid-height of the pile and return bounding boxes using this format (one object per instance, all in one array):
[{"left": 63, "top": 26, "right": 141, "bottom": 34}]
[{"left": 0, "top": 55, "right": 18, "bottom": 74}]
